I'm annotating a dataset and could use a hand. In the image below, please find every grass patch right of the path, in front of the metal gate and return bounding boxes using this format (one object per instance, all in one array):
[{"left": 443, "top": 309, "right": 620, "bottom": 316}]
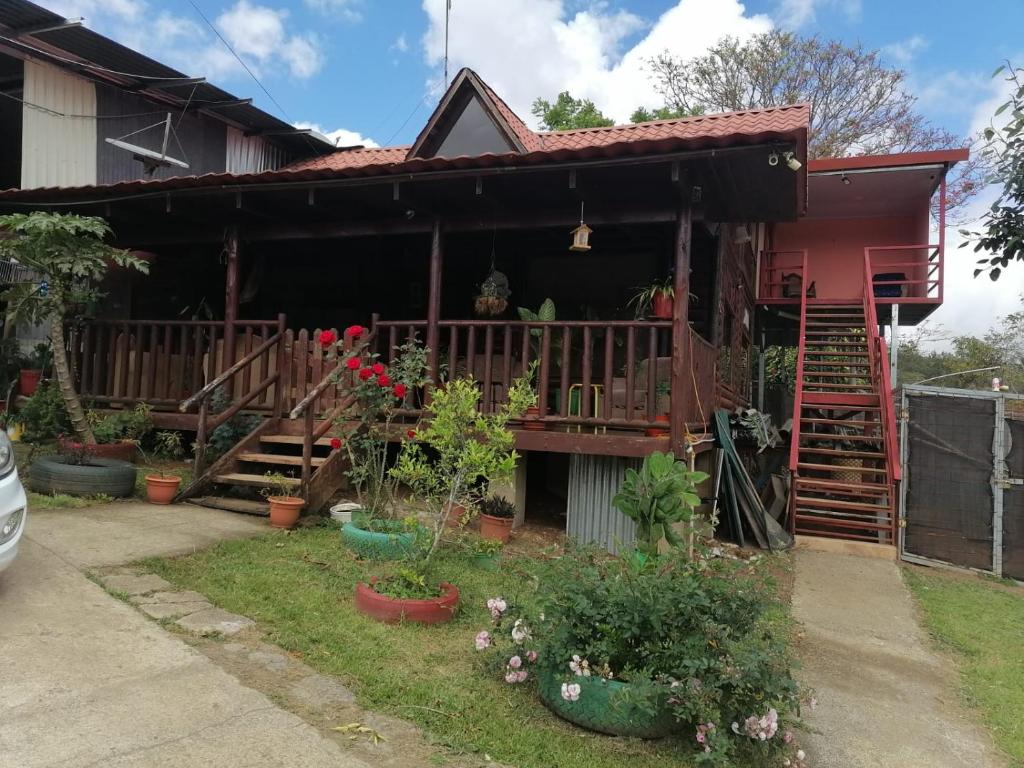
[{"left": 903, "top": 567, "right": 1024, "bottom": 766}]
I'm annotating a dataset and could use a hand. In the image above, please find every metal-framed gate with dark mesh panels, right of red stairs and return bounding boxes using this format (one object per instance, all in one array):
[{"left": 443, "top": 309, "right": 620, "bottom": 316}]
[{"left": 899, "top": 384, "right": 1024, "bottom": 580}]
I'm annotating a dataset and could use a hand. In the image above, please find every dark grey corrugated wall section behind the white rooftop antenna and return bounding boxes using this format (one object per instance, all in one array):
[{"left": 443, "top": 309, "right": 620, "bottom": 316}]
[{"left": 94, "top": 84, "right": 227, "bottom": 184}]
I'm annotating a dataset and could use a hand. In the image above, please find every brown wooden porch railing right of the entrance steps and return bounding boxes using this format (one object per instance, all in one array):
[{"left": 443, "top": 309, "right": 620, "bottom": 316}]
[{"left": 374, "top": 321, "right": 716, "bottom": 429}]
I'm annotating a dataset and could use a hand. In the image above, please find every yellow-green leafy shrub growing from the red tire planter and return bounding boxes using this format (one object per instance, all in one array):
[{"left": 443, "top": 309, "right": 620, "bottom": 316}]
[{"left": 391, "top": 372, "right": 535, "bottom": 573}]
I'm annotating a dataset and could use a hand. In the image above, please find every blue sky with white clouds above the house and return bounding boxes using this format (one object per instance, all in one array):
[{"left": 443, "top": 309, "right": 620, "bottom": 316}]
[{"left": 44, "top": 0, "right": 1024, "bottom": 342}]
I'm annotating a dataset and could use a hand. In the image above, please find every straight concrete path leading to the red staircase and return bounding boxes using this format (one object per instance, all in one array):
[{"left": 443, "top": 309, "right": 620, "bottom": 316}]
[{"left": 793, "top": 550, "right": 1005, "bottom": 768}]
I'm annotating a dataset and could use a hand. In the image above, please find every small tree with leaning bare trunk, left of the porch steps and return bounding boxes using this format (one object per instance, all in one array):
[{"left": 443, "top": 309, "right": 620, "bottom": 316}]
[{"left": 0, "top": 211, "right": 150, "bottom": 444}]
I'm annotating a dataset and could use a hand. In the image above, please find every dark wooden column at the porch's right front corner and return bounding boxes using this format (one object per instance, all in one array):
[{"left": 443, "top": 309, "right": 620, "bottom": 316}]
[{"left": 669, "top": 198, "right": 696, "bottom": 459}]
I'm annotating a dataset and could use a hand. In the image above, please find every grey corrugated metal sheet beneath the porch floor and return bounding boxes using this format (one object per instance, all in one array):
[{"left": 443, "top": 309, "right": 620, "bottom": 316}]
[{"left": 566, "top": 454, "right": 640, "bottom": 553}]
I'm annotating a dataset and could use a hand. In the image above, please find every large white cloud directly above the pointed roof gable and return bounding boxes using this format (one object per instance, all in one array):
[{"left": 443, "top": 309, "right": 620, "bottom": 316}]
[{"left": 423, "top": 0, "right": 771, "bottom": 125}]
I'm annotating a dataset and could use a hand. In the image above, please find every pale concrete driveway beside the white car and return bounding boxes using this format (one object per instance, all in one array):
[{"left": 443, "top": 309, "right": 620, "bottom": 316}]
[{"left": 0, "top": 504, "right": 369, "bottom": 768}]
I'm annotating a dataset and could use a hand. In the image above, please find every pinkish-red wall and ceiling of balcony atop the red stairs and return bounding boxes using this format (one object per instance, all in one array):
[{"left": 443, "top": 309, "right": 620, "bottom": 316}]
[{"left": 771, "top": 217, "right": 929, "bottom": 299}]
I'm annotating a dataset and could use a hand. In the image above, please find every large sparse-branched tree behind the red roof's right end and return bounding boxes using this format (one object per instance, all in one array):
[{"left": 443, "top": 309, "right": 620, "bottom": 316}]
[{"left": 648, "top": 30, "right": 984, "bottom": 208}]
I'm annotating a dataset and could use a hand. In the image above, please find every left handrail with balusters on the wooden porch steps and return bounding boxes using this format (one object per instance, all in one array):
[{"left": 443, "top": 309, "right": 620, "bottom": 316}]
[{"left": 178, "top": 314, "right": 285, "bottom": 475}]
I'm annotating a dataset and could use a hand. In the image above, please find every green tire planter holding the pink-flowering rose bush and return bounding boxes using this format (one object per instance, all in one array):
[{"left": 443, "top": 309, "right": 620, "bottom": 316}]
[{"left": 538, "top": 672, "right": 679, "bottom": 738}]
